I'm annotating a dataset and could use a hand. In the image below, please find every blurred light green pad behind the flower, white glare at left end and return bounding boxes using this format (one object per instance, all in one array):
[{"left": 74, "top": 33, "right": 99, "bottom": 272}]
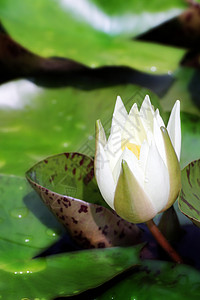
[{"left": 0, "top": 81, "right": 160, "bottom": 175}]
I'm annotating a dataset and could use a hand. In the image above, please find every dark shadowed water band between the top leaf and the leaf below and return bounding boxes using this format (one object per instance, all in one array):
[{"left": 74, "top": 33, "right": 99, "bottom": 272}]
[{"left": 0, "top": 27, "right": 173, "bottom": 94}]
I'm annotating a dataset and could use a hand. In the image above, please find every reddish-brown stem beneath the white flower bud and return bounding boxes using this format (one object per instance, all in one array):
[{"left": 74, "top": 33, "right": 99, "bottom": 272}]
[{"left": 146, "top": 220, "right": 183, "bottom": 264}]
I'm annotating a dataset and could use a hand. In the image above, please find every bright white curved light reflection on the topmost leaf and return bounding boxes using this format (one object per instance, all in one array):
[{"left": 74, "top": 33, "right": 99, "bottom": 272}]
[{"left": 59, "top": 0, "right": 181, "bottom": 35}]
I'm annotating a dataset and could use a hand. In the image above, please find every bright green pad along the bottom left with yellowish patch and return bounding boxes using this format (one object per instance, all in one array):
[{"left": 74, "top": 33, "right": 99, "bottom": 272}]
[{"left": 0, "top": 244, "right": 142, "bottom": 300}]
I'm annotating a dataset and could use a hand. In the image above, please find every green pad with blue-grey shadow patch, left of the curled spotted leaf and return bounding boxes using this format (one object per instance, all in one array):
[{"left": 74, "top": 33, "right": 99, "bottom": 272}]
[{"left": 0, "top": 175, "right": 64, "bottom": 251}]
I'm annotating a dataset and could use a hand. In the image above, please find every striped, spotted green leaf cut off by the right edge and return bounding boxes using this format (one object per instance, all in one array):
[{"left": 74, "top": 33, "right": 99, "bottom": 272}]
[{"left": 179, "top": 160, "right": 200, "bottom": 227}]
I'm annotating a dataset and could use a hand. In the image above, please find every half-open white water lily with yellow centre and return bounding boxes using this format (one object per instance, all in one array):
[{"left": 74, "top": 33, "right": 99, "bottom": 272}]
[{"left": 95, "top": 95, "right": 181, "bottom": 223}]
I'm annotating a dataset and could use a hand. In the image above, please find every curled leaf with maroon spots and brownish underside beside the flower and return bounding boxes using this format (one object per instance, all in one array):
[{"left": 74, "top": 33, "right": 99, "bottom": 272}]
[{"left": 26, "top": 153, "right": 140, "bottom": 248}]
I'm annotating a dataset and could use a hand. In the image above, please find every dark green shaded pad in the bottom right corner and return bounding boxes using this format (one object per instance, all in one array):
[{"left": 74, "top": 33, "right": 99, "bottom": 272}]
[{"left": 95, "top": 261, "right": 200, "bottom": 300}]
